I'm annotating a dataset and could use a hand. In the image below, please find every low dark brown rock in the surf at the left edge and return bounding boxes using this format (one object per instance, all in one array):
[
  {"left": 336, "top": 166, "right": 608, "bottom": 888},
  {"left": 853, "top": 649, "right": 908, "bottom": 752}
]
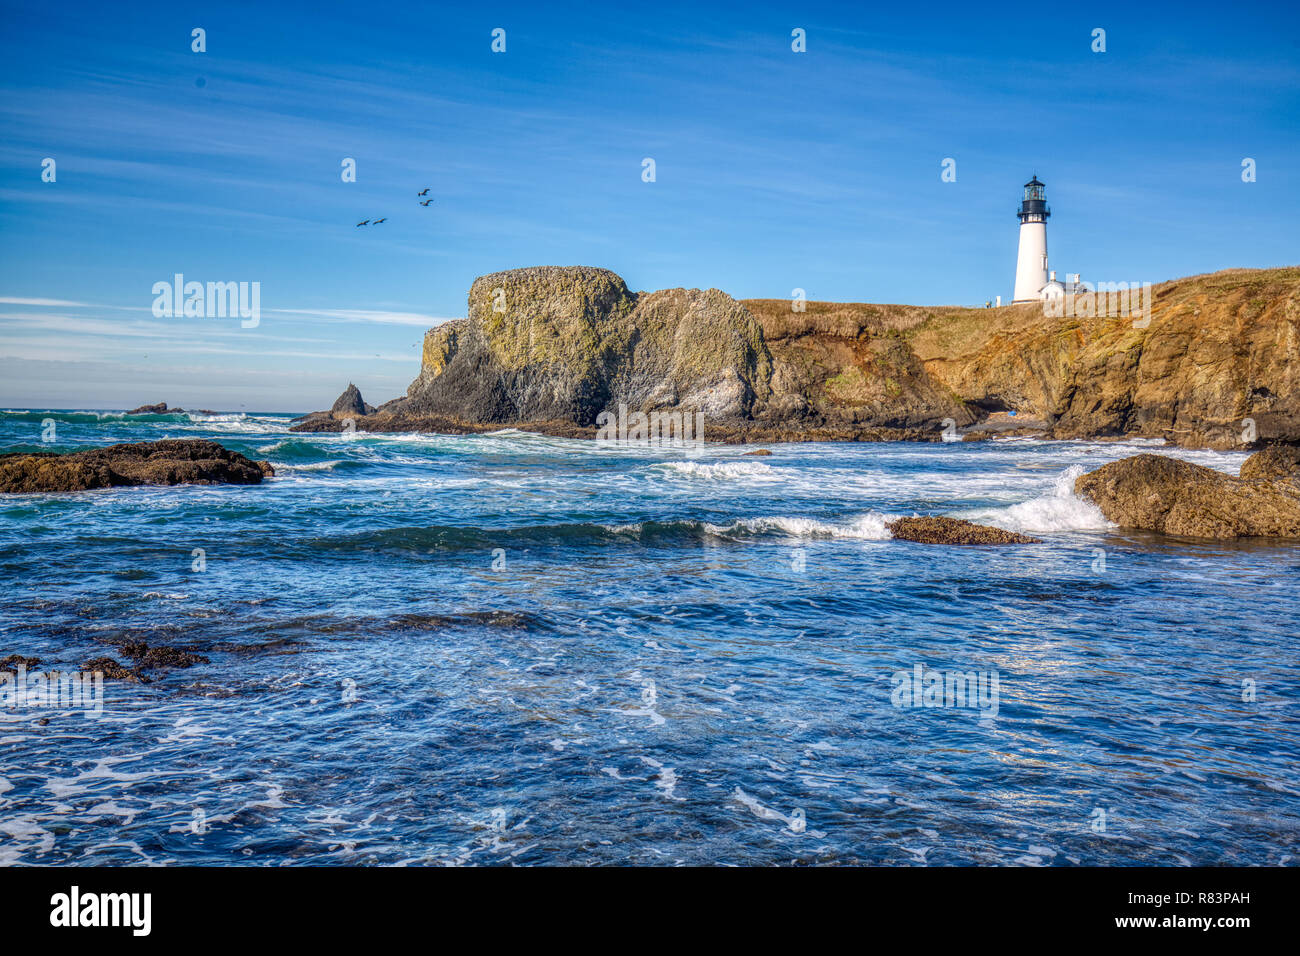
[{"left": 0, "top": 438, "right": 274, "bottom": 493}]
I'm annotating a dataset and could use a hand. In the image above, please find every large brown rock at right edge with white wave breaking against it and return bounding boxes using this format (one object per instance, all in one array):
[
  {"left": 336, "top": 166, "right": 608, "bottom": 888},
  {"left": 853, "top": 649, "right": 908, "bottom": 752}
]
[{"left": 1074, "top": 451, "right": 1300, "bottom": 538}]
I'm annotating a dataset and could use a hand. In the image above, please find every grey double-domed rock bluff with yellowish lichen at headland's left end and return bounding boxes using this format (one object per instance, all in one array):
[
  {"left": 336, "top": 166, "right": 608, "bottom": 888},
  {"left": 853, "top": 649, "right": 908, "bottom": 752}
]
[{"left": 400, "top": 267, "right": 771, "bottom": 425}]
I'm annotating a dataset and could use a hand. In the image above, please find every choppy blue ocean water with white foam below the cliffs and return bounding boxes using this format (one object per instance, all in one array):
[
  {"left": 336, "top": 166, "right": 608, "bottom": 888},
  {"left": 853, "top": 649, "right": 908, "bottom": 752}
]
[{"left": 0, "top": 411, "right": 1300, "bottom": 865}]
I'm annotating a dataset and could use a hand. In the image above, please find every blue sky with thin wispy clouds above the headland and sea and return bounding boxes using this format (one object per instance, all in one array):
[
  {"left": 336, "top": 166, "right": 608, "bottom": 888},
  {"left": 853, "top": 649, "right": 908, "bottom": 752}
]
[{"left": 0, "top": 0, "right": 1300, "bottom": 411}]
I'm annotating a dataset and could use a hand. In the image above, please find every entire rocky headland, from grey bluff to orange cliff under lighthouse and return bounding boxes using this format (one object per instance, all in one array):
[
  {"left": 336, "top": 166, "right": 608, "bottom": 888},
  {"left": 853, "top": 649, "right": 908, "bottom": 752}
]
[{"left": 302, "top": 257, "right": 1300, "bottom": 447}]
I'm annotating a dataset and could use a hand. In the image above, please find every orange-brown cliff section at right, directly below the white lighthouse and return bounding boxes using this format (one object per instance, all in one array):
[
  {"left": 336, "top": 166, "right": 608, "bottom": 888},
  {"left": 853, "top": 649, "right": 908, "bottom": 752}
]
[{"left": 909, "top": 268, "right": 1300, "bottom": 449}]
